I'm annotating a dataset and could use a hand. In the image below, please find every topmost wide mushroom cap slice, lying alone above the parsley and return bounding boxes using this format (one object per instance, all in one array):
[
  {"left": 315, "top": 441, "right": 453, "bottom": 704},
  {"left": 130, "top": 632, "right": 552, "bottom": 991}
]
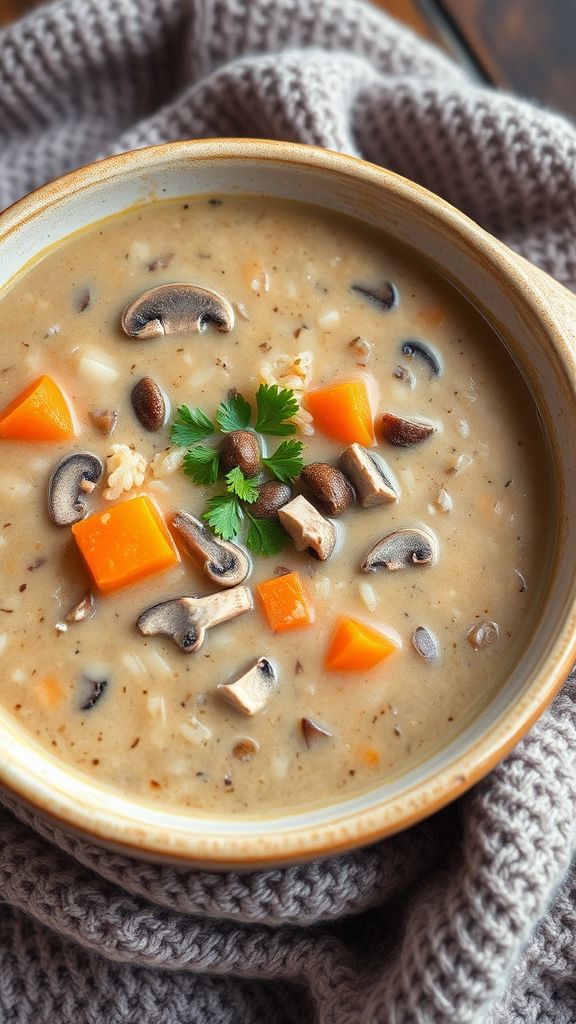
[{"left": 122, "top": 284, "right": 234, "bottom": 339}]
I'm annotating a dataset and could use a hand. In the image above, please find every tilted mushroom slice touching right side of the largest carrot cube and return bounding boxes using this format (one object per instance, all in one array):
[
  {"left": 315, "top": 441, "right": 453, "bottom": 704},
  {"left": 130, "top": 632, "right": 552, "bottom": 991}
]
[{"left": 171, "top": 511, "right": 250, "bottom": 587}]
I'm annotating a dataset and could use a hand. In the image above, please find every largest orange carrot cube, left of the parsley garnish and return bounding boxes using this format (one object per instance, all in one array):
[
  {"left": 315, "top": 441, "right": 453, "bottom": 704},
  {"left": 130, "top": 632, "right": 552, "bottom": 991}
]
[{"left": 72, "top": 495, "right": 179, "bottom": 594}]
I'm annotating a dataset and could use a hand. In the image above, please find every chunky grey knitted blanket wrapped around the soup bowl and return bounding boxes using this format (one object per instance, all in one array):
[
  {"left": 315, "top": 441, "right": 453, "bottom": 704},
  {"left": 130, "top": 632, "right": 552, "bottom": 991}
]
[{"left": 0, "top": 0, "right": 576, "bottom": 1024}]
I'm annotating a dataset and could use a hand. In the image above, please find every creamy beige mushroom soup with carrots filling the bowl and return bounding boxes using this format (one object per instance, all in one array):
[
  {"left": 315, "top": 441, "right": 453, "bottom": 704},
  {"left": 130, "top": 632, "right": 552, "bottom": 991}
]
[{"left": 0, "top": 197, "right": 553, "bottom": 815}]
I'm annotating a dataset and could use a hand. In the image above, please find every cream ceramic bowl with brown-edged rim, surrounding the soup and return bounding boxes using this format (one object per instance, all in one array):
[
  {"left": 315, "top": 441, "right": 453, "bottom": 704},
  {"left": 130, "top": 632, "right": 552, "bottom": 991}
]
[{"left": 0, "top": 139, "right": 576, "bottom": 869}]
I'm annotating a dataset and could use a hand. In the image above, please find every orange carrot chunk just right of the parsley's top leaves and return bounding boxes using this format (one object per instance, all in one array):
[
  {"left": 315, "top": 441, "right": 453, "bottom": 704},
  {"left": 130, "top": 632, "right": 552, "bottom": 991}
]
[{"left": 304, "top": 380, "right": 374, "bottom": 445}]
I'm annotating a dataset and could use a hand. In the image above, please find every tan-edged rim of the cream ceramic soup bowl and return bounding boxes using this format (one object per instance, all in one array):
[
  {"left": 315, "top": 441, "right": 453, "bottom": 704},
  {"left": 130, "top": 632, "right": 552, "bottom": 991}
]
[{"left": 0, "top": 138, "right": 576, "bottom": 870}]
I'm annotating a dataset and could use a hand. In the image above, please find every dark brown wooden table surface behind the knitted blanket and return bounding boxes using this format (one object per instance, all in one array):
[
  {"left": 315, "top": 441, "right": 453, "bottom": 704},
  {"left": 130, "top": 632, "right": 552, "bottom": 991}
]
[{"left": 0, "top": 0, "right": 576, "bottom": 119}]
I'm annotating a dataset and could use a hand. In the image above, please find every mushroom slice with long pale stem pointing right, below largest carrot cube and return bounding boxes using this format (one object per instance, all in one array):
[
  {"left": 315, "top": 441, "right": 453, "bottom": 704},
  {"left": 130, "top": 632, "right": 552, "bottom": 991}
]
[{"left": 136, "top": 587, "right": 254, "bottom": 654}]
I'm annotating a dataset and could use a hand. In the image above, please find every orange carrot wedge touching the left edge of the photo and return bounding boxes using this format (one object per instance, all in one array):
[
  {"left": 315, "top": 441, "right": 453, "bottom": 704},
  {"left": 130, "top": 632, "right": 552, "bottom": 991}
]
[{"left": 0, "top": 374, "right": 76, "bottom": 441}]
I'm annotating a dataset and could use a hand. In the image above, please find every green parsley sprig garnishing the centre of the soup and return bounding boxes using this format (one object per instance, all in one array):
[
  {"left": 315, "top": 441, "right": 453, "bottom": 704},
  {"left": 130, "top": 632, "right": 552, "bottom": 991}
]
[{"left": 170, "top": 384, "right": 303, "bottom": 555}]
